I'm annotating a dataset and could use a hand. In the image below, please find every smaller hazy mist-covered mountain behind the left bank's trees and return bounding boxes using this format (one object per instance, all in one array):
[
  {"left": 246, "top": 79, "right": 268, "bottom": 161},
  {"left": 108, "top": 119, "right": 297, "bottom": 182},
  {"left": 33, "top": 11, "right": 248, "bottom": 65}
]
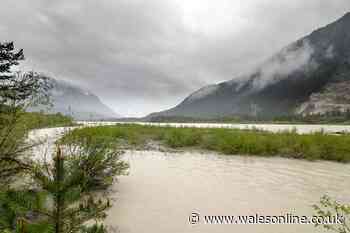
[{"left": 30, "top": 78, "right": 120, "bottom": 120}]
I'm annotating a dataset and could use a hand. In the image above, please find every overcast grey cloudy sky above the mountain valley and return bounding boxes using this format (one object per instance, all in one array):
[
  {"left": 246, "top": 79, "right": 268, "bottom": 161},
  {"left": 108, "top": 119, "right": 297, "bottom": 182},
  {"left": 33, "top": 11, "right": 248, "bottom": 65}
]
[{"left": 0, "top": 0, "right": 350, "bottom": 116}]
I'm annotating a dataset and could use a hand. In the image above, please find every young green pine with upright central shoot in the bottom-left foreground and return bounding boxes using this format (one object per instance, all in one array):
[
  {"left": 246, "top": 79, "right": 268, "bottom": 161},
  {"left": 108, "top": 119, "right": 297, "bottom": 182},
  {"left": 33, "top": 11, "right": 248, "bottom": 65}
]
[{"left": 0, "top": 147, "right": 124, "bottom": 233}]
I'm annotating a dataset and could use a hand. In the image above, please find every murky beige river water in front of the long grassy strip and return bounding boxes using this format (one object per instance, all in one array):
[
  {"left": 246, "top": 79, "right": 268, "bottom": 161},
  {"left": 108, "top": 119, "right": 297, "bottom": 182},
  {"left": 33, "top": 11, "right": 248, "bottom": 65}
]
[{"left": 30, "top": 125, "right": 350, "bottom": 233}]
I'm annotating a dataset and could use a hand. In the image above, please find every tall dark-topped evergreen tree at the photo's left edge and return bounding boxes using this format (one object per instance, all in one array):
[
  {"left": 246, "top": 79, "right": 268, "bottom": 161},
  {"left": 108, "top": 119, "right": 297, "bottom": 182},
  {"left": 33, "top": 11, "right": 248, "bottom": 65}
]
[{"left": 0, "top": 42, "right": 50, "bottom": 186}]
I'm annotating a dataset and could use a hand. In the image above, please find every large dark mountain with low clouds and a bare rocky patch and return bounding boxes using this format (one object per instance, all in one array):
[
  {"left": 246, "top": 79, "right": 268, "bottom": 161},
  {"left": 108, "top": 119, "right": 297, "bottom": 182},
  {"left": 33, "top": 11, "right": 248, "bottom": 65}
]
[{"left": 146, "top": 13, "right": 350, "bottom": 119}]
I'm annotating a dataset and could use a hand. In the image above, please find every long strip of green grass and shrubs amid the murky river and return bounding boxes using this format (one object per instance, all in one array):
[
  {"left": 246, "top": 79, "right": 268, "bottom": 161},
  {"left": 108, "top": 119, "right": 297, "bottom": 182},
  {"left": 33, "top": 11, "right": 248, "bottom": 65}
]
[{"left": 64, "top": 124, "right": 350, "bottom": 162}]
